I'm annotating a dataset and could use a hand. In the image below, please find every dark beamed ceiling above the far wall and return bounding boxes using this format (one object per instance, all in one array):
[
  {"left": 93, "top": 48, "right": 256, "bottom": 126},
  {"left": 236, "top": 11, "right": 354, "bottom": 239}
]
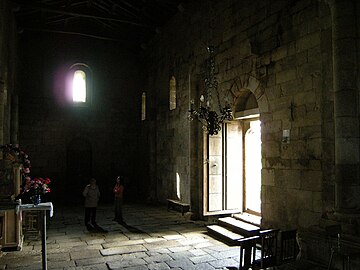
[{"left": 11, "top": 0, "right": 186, "bottom": 46}]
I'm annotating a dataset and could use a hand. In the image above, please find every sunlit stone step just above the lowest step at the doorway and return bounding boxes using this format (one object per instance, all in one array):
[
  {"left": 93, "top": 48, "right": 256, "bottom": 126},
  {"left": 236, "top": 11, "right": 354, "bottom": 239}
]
[{"left": 218, "top": 217, "right": 260, "bottom": 237}]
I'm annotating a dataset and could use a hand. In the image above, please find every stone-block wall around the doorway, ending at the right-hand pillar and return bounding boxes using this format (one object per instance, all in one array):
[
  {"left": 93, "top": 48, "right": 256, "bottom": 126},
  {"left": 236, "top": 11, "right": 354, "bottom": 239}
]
[{"left": 144, "top": 0, "right": 334, "bottom": 228}]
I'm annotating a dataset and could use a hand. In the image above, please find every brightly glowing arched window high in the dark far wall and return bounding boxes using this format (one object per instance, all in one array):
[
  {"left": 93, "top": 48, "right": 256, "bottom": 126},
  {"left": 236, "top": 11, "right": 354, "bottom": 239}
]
[{"left": 68, "top": 63, "right": 92, "bottom": 106}]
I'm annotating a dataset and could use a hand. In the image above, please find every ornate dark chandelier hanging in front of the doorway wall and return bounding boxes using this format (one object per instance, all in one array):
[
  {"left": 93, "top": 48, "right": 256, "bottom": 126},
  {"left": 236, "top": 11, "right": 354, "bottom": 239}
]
[{"left": 188, "top": 46, "right": 233, "bottom": 135}]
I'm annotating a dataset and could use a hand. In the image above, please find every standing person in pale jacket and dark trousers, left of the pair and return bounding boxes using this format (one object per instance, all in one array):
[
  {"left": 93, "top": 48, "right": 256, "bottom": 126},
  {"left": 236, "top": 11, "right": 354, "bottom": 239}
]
[{"left": 83, "top": 178, "right": 100, "bottom": 231}]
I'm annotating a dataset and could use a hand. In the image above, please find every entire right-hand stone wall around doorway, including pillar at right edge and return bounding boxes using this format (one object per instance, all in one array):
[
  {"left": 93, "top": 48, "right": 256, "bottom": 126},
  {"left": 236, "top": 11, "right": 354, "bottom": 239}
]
[{"left": 144, "top": 0, "right": 360, "bottom": 266}]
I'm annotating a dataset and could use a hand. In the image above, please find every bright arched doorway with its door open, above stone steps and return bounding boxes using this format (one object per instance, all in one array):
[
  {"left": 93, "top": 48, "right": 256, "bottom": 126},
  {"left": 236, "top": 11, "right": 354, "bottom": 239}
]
[{"left": 204, "top": 90, "right": 262, "bottom": 216}]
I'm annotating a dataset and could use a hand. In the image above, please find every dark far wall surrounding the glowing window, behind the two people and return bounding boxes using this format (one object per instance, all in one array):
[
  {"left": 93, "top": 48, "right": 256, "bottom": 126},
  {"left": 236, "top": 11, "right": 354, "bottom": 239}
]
[{"left": 16, "top": 32, "right": 143, "bottom": 202}]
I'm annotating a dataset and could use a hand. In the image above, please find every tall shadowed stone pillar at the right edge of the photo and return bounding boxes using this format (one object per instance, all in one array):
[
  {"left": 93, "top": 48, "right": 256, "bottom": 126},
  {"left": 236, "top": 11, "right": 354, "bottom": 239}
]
[{"left": 330, "top": 0, "right": 360, "bottom": 214}]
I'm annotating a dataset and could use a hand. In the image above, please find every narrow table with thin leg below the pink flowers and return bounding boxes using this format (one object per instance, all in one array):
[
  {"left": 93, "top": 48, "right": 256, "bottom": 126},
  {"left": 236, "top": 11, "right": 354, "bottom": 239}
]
[{"left": 16, "top": 202, "right": 54, "bottom": 270}]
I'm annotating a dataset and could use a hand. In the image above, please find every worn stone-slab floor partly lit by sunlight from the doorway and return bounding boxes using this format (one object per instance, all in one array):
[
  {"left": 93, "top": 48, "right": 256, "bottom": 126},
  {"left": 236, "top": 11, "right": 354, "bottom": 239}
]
[{"left": 0, "top": 204, "right": 321, "bottom": 270}]
